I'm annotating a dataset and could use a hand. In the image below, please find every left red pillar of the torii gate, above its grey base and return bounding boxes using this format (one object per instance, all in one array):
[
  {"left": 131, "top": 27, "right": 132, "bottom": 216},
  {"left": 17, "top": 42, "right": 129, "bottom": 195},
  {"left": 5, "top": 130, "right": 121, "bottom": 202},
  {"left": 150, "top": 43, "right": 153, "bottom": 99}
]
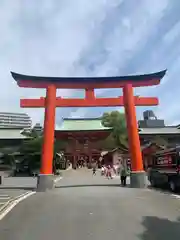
[{"left": 40, "top": 85, "right": 56, "bottom": 175}]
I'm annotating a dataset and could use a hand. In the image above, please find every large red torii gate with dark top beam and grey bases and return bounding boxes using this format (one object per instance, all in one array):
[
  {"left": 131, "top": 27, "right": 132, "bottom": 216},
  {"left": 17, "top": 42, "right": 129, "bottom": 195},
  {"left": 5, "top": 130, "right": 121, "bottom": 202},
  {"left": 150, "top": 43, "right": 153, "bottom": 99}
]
[{"left": 11, "top": 70, "right": 166, "bottom": 191}]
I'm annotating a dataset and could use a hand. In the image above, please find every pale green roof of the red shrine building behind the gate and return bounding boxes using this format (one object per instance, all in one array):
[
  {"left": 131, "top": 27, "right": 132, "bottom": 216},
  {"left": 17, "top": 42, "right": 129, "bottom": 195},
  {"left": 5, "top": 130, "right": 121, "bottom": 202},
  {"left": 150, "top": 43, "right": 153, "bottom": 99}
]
[{"left": 56, "top": 118, "right": 111, "bottom": 132}]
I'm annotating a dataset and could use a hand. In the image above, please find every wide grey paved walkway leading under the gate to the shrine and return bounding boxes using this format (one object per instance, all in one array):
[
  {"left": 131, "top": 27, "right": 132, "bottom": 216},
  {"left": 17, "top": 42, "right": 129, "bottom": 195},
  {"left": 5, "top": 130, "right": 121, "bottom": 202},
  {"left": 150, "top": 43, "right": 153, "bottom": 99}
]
[{"left": 0, "top": 170, "right": 180, "bottom": 240}]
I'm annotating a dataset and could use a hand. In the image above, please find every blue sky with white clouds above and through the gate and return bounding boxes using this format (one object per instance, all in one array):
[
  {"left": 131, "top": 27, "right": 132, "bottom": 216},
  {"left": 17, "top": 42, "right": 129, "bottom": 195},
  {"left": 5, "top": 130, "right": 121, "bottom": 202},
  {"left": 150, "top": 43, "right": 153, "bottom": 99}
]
[{"left": 0, "top": 0, "right": 180, "bottom": 125}]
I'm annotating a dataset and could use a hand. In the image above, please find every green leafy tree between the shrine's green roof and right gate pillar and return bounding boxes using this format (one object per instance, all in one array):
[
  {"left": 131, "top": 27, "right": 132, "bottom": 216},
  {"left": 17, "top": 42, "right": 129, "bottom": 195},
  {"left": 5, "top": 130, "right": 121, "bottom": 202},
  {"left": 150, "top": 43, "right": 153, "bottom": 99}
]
[{"left": 102, "top": 111, "right": 128, "bottom": 147}]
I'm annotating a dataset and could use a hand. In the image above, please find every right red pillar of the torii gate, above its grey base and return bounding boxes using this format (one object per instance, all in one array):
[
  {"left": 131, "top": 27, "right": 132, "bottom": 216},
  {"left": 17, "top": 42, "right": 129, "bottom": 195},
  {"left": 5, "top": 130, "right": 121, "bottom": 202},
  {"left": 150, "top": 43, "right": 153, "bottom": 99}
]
[{"left": 123, "top": 84, "right": 143, "bottom": 172}]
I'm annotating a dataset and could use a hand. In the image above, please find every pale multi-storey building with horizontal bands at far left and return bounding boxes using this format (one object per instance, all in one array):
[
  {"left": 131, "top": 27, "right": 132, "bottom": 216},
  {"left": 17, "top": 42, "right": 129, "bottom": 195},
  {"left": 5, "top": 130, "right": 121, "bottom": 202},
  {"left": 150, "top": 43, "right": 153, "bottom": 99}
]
[{"left": 0, "top": 112, "right": 32, "bottom": 129}]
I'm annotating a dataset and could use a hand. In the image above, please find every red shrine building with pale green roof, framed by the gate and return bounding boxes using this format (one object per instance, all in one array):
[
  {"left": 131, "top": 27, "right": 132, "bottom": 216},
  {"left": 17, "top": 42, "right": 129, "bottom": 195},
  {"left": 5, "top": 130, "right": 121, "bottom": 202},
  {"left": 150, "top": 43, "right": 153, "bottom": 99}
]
[{"left": 55, "top": 118, "right": 112, "bottom": 168}]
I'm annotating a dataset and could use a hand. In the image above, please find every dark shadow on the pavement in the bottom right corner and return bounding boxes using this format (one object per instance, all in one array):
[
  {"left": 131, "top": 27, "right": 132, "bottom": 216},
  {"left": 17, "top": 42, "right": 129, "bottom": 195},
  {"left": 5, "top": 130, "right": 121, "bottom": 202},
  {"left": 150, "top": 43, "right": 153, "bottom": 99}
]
[{"left": 138, "top": 216, "right": 180, "bottom": 240}]
